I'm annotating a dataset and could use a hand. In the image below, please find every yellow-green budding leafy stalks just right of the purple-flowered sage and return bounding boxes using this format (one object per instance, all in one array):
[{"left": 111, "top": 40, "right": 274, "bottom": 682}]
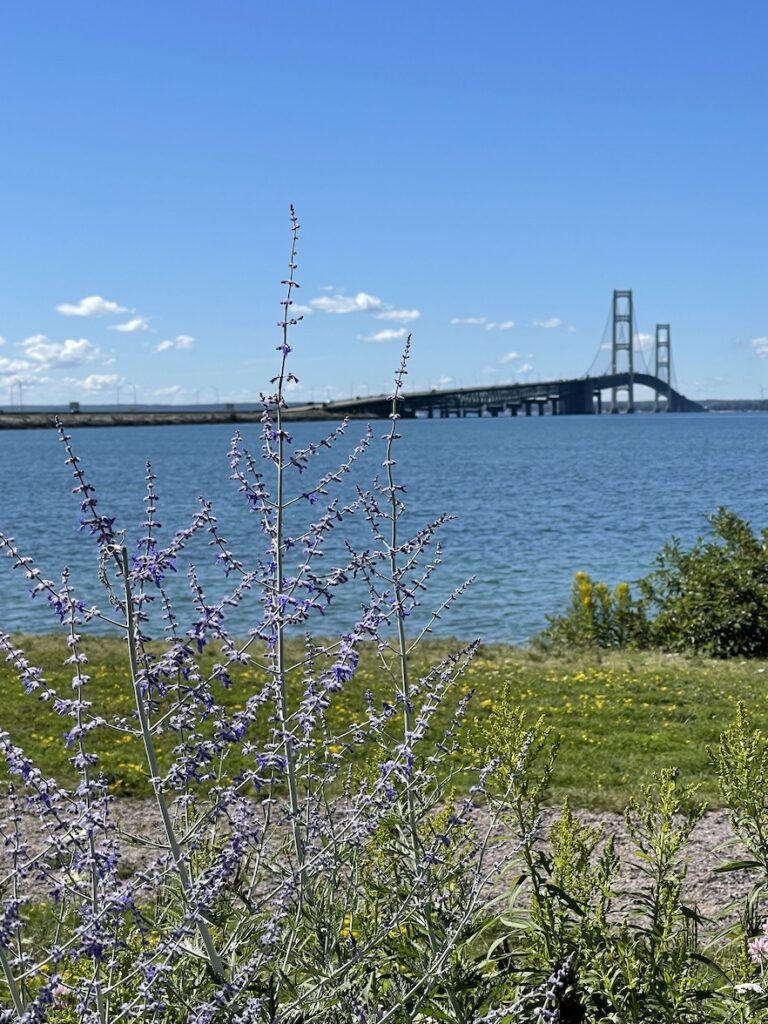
[{"left": 482, "top": 712, "right": 729, "bottom": 1024}]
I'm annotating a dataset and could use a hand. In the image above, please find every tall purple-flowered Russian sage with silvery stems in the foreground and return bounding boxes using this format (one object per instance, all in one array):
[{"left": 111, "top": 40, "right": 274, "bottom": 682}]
[{"left": 0, "top": 210, "right": 536, "bottom": 1024}]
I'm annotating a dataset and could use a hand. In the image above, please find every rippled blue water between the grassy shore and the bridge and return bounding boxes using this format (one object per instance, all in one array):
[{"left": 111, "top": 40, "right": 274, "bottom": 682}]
[{"left": 0, "top": 414, "right": 768, "bottom": 642}]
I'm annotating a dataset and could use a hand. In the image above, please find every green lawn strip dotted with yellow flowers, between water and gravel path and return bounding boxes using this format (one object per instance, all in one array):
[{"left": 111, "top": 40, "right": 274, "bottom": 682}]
[{"left": 0, "top": 637, "right": 768, "bottom": 809}]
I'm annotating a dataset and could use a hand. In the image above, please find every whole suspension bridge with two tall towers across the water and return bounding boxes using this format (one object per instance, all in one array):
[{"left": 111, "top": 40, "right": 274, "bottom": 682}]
[{"left": 303, "top": 291, "right": 707, "bottom": 419}]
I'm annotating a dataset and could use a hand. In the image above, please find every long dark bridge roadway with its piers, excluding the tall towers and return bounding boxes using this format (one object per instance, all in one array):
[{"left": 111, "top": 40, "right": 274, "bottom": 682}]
[{"left": 291, "top": 373, "right": 707, "bottom": 419}]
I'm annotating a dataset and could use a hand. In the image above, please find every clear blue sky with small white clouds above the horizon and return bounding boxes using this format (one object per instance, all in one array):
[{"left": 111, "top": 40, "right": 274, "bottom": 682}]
[{"left": 0, "top": 0, "right": 768, "bottom": 404}]
